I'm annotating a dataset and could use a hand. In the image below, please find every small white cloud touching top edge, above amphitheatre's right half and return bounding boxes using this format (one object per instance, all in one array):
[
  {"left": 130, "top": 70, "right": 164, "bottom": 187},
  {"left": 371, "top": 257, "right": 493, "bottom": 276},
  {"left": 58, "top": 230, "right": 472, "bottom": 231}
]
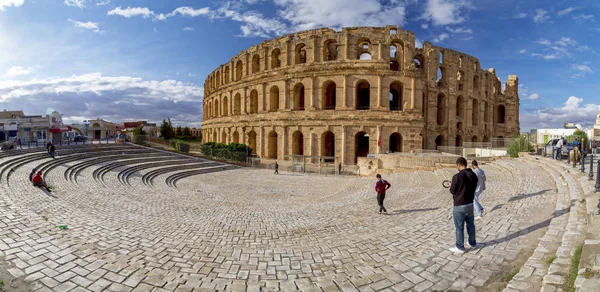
[{"left": 423, "top": 0, "right": 473, "bottom": 25}]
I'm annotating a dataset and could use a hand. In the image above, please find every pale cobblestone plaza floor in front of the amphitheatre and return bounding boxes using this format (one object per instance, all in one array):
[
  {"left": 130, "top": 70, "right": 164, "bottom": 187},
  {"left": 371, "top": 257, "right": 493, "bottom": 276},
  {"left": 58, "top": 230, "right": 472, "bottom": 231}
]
[{"left": 0, "top": 147, "right": 556, "bottom": 291}]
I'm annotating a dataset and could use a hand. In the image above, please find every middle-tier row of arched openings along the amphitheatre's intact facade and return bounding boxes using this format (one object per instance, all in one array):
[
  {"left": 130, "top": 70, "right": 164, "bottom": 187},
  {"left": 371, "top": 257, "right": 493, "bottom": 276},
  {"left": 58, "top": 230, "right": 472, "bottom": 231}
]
[{"left": 204, "top": 80, "right": 404, "bottom": 118}]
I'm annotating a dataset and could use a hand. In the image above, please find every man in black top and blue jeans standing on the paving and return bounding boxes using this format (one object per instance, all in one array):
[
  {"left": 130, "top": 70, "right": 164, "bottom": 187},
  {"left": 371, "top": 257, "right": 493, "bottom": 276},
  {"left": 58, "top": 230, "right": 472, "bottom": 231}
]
[{"left": 450, "top": 157, "right": 478, "bottom": 253}]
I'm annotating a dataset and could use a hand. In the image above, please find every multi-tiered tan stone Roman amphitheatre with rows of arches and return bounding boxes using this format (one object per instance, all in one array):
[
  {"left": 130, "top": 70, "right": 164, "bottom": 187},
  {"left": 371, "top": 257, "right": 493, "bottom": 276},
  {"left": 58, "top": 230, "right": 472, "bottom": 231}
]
[{"left": 202, "top": 26, "right": 519, "bottom": 164}]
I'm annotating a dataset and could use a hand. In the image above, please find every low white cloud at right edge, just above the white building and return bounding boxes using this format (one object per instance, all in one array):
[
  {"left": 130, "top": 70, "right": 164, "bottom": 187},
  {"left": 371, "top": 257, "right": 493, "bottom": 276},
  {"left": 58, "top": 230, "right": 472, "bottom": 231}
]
[{"left": 521, "top": 96, "right": 600, "bottom": 128}]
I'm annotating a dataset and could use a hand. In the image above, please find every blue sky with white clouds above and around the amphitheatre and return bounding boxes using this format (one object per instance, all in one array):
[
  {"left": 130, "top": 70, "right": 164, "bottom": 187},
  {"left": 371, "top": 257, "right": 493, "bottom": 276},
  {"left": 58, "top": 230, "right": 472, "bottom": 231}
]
[{"left": 0, "top": 0, "right": 600, "bottom": 130}]
